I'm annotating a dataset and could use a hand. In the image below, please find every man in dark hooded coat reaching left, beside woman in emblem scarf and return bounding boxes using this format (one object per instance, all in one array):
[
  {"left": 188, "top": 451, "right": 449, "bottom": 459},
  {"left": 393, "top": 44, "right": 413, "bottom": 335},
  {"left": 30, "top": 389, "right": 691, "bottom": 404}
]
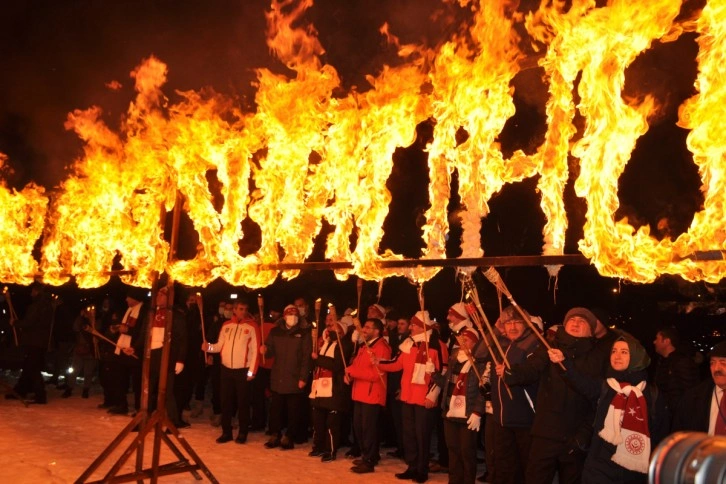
[{"left": 496, "top": 307, "right": 607, "bottom": 484}]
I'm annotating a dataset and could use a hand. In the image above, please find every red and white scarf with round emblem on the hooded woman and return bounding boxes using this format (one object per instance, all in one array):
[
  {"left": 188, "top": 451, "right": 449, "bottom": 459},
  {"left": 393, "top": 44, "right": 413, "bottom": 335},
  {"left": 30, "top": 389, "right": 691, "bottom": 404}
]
[{"left": 599, "top": 378, "right": 650, "bottom": 474}]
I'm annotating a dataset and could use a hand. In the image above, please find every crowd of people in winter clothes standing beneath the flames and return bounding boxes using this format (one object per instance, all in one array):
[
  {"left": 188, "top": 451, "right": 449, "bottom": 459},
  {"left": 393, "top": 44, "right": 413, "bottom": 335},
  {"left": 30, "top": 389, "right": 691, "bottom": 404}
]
[{"left": 6, "top": 283, "right": 726, "bottom": 484}]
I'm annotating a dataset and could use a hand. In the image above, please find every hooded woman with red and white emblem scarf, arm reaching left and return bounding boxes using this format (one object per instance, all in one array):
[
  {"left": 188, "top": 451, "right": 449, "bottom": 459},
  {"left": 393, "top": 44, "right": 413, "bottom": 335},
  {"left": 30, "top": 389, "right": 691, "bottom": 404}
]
[{"left": 549, "top": 331, "right": 669, "bottom": 483}]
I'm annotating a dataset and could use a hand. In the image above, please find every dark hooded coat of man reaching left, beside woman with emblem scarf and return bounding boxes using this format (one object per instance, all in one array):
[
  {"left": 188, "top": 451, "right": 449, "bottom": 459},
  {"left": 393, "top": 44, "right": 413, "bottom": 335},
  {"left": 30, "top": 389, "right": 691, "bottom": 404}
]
[{"left": 504, "top": 328, "right": 607, "bottom": 451}]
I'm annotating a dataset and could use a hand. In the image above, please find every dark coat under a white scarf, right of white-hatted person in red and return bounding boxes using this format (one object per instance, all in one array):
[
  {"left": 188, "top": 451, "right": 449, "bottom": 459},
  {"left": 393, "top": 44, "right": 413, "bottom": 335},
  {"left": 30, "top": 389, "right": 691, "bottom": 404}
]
[{"left": 432, "top": 341, "right": 488, "bottom": 423}]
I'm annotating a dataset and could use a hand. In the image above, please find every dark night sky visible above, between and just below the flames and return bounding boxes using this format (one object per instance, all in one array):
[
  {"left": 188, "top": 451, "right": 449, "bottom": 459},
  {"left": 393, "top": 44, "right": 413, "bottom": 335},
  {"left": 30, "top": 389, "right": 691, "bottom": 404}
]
[{"left": 0, "top": 0, "right": 724, "bottom": 346}]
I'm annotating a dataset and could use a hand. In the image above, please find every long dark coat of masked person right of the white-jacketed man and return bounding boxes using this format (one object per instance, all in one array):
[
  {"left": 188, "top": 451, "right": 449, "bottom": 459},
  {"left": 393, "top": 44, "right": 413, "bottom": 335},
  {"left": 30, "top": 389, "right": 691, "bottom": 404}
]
[{"left": 265, "top": 321, "right": 313, "bottom": 394}]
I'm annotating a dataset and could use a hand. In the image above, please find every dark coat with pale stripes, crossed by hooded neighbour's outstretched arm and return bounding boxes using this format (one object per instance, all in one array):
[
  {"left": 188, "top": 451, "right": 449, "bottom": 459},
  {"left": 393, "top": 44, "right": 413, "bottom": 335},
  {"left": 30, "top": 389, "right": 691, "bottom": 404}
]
[{"left": 491, "top": 328, "right": 539, "bottom": 428}]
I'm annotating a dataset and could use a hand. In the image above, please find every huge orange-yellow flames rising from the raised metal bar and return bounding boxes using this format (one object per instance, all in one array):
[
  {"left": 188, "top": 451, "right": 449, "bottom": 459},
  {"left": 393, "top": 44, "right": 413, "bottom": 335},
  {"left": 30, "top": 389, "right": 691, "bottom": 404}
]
[{"left": 0, "top": 0, "right": 726, "bottom": 288}]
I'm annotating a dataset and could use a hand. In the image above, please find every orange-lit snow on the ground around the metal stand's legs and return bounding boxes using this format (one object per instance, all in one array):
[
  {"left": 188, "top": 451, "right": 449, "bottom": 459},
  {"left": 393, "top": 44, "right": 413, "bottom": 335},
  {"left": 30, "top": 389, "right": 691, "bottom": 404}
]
[{"left": 0, "top": 379, "right": 456, "bottom": 484}]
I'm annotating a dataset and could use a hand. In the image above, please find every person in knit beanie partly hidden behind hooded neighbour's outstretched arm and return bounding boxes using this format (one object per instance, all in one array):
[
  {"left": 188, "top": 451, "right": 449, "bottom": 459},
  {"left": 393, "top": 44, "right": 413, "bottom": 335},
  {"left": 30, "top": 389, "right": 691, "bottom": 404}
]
[{"left": 491, "top": 306, "right": 540, "bottom": 484}]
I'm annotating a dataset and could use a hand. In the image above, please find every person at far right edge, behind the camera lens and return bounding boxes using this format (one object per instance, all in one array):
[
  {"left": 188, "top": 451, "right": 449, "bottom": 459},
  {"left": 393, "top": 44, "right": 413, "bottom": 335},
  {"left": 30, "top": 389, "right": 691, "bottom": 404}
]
[{"left": 673, "top": 340, "right": 726, "bottom": 436}]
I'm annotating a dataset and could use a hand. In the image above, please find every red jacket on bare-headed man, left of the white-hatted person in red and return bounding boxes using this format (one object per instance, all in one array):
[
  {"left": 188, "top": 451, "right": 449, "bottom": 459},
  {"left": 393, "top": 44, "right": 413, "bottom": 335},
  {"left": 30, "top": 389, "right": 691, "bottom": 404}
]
[{"left": 348, "top": 338, "right": 391, "bottom": 406}]
